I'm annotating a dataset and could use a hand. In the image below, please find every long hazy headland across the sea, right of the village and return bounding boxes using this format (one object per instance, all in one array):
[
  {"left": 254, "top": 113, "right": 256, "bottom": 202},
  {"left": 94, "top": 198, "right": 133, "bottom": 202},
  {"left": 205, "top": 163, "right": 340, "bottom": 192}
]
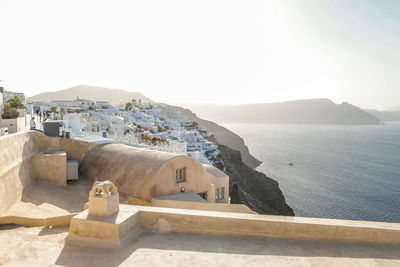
[{"left": 188, "top": 99, "right": 379, "bottom": 124}]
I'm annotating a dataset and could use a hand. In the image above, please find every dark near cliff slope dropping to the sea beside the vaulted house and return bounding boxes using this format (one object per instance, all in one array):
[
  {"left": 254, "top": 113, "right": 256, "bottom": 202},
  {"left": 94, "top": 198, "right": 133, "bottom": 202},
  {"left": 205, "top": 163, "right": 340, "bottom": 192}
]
[{"left": 219, "top": 145, "right": 294, "bottom": 216}]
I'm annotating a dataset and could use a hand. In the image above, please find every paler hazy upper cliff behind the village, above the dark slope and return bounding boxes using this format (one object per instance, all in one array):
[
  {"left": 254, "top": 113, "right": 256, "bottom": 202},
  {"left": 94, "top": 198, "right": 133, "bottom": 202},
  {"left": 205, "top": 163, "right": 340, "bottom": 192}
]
[{"left": 171, "top": 106, "right": 261, "bottom": 169}]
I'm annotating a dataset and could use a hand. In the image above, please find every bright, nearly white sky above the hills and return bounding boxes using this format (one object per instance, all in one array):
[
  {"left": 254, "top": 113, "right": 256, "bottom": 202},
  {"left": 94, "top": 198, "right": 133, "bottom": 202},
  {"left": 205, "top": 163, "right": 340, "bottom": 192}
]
[{"left": 0, "top": 0, "right": 400, "bottom": 110}]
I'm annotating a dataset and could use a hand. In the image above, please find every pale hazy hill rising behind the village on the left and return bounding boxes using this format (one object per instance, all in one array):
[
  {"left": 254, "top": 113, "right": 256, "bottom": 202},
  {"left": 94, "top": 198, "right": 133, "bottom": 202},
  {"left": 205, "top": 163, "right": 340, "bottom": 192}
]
[{"left": 30, "top": 85, "right": 153, "bottom": 105}]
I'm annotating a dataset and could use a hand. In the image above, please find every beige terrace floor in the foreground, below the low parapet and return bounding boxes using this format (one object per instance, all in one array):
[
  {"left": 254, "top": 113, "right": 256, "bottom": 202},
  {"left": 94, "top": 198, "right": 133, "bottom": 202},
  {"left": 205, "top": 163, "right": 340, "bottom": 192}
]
[{"left": 0, "top": 225, "right": 400, "bottom": 267}]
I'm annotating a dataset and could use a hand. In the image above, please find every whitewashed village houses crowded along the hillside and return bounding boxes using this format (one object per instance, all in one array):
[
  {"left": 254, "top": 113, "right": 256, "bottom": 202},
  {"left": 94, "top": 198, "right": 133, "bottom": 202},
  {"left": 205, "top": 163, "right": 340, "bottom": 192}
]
[{"left": 1, "top": 87, "right": 223, "bottom": 166}]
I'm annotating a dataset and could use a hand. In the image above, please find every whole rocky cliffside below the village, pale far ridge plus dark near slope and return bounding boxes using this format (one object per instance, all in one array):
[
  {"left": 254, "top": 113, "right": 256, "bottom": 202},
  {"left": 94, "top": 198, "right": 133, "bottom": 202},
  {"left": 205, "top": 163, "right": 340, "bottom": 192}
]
[{"left": 169, "top": 107, "right": 294, "bottom": 216}]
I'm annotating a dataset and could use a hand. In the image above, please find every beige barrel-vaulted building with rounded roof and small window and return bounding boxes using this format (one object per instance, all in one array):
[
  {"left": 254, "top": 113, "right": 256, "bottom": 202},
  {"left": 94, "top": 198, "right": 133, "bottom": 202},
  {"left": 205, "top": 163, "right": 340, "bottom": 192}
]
[{"left": 80, "top": 144, "right": 211, "bottom": 202}]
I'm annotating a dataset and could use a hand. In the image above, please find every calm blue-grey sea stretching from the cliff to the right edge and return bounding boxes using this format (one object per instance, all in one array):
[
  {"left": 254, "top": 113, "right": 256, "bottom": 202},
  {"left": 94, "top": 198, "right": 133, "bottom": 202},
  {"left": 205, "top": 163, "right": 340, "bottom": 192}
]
[{"left": 223, "top": 123, "right": 400, "bottom": 222}]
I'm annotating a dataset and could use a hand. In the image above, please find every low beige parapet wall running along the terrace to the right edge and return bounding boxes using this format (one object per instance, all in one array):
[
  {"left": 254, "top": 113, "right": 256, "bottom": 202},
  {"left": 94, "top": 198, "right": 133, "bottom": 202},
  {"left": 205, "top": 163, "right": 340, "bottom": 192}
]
[{"left": 71, "top": 205, "right": 400, "bottom": 245}]
